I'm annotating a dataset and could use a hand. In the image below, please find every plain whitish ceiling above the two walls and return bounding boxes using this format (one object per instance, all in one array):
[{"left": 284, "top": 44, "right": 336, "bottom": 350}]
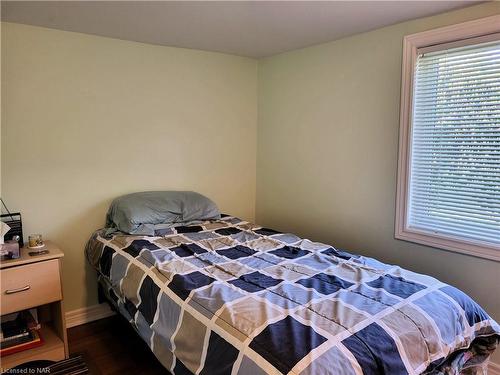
[{"left": 2, "top": 0, "right": 477, "bottom": 58}]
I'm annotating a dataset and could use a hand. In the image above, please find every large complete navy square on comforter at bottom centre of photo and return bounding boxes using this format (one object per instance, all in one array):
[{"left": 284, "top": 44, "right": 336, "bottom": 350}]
[{"left": 250, "top": 316, "right": 326, "bottom": 374}]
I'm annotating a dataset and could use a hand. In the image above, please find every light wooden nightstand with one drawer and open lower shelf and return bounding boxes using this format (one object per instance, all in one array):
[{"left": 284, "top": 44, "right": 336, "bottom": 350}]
[{"left": 0, "top": 241, "right": 68, "bottom": 370}]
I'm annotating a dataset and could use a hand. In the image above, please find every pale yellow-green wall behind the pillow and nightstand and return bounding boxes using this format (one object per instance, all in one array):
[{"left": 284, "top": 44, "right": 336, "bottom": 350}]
[{"left": 2, "top": 24, "right": 257, "bottom": 310}]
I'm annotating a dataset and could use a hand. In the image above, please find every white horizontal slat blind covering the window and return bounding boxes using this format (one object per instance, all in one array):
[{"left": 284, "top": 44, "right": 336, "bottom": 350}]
[{"left": 407, "top": 41, "right": 500, "bottom": 244}]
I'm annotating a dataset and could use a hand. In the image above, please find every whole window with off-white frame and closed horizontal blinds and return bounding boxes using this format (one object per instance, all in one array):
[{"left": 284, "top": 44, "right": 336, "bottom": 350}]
[{"left": 396, "top": 16, "right": 500, "bottom": 260}]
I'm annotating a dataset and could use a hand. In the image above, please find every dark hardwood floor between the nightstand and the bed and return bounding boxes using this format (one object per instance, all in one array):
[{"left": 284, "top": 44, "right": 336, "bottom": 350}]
[{"left": 68, "top": 316, "right": 169, "bottom": 375}]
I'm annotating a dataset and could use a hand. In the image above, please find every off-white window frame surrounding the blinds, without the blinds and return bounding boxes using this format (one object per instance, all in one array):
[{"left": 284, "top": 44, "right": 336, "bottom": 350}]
[{"left": 395, "top": 15, "right": 500, "bottom": 261}]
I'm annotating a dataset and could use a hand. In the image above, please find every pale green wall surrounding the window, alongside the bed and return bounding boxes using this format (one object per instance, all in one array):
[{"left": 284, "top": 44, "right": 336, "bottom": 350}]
[{"left": 256, "top": 3, "right": 500, "bottom": 363}]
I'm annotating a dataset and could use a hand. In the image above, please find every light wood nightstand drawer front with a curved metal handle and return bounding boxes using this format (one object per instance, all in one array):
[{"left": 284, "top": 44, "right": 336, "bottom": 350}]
[{"left": 0, "top": 259, "right": 62, "bottom": 315}]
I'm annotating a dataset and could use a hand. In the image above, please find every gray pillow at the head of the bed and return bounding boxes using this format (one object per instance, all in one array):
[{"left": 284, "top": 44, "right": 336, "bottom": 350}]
[{"left": 106, "top": 191, "right": 220, "bottom": 236}]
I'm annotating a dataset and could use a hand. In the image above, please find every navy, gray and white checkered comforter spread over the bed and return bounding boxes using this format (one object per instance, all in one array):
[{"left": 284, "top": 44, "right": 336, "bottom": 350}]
[{"left": 86, "top": 216, "right": 500, "bottom": 375}]
